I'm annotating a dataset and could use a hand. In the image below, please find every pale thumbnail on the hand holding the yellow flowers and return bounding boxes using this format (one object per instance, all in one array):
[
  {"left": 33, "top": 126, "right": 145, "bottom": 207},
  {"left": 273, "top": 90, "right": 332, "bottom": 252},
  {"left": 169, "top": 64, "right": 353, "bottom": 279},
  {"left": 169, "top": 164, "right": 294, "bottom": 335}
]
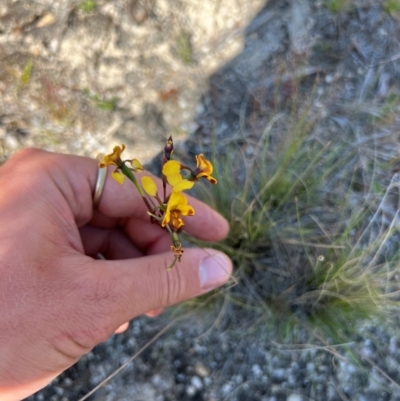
[{"left": 199, "top": 254, "right": 232, "bottom": 290}]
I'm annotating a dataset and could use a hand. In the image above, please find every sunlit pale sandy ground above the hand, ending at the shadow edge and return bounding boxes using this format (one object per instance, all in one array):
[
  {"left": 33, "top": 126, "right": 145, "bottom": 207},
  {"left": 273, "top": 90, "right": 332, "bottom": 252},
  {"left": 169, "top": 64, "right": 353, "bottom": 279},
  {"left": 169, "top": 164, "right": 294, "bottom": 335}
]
[{"left": 0, "top": 0, "right": 262, "bottom": 162}]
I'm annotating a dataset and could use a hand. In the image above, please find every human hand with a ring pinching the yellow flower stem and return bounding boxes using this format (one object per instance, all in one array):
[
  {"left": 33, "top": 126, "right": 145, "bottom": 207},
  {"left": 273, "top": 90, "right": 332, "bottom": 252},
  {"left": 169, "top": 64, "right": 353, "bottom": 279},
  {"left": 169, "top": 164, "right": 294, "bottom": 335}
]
[{"left": 0, "top": 149, "right": 232, "bottom": 401}]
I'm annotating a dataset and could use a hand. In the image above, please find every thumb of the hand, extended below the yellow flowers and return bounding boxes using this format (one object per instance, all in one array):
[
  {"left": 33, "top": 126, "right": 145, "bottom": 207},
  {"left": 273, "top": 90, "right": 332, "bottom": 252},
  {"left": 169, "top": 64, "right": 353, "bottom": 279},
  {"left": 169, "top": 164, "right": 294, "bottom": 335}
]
[{"left": 86, "top": 248, "right": 232, "bottom": 330}]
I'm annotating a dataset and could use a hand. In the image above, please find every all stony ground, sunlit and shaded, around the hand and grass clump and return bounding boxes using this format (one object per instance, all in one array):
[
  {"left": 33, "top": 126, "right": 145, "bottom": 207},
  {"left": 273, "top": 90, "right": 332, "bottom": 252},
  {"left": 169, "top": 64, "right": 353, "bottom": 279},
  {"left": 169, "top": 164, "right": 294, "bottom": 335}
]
[{"left": 0, "top": 0, "right": 400, "bottom": 401}]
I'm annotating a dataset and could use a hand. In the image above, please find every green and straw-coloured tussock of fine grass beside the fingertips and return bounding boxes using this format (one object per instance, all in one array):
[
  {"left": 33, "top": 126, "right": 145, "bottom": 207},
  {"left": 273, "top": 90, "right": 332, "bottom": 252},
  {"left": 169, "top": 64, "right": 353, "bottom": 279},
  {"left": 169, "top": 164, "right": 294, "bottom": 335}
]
[{"left": 188, "top": 100, "right": 400, "bottom": 345}]
